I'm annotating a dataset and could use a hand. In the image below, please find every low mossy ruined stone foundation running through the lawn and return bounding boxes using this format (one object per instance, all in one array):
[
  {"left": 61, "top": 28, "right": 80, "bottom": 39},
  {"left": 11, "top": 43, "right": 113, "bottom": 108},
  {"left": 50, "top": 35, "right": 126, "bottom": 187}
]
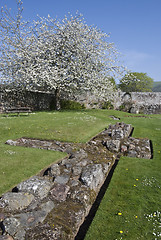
[{"left": 0, "top": 123, "right": 151, "bottom": 240}]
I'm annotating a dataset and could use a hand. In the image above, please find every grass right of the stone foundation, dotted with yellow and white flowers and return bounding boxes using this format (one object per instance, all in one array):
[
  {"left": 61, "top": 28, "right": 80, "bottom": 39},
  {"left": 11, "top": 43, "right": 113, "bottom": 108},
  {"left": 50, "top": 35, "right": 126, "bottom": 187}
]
[{"left": 85, "top": 115, "right": 161, "bottom": 240}]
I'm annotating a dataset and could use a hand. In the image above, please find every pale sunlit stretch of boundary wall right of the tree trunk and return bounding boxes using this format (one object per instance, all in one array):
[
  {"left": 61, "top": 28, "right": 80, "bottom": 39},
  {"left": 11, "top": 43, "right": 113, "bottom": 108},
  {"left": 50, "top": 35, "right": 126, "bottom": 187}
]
[{"left": 70, "top": 91, "right": 161, "bottom": 114}]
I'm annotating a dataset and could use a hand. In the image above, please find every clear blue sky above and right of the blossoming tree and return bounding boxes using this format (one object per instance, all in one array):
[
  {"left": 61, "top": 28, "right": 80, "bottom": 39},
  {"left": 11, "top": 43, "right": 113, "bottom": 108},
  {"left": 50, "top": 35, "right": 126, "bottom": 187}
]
[{"left": 0, "top": 0, "right": 161, "bottom": 81}]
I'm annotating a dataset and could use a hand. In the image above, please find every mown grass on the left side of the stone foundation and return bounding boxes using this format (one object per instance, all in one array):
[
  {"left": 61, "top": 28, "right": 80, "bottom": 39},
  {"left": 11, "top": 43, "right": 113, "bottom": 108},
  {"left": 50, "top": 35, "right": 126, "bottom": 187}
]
[{"left": 0, "top": 110, "right": 118, "bottom": 194}]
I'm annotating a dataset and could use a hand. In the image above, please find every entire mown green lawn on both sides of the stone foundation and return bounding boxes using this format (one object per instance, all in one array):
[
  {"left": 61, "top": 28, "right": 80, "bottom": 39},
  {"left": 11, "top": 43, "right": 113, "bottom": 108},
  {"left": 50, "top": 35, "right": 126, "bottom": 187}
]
[{"left": 0, "top": 110, "right": 161, "bottom": 240}]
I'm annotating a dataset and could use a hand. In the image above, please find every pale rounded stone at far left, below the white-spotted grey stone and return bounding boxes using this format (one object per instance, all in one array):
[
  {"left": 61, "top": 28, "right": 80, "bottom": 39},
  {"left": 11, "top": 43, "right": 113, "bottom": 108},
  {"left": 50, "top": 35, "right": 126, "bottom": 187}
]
[{"left": 2, "top": 192, "right": 34, "bottom": 211}]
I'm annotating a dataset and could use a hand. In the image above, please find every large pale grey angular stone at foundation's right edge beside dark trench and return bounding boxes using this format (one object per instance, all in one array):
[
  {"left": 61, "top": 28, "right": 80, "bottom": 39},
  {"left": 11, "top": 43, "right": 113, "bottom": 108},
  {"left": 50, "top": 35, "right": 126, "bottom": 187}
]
[{"left": 80, "top": 164, "right": 104, "bottom": 190}]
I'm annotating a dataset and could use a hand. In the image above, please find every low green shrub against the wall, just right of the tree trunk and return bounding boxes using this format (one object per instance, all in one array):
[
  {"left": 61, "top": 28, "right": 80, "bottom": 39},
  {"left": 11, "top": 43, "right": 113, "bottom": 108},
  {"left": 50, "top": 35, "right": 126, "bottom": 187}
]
[{"left": 60, "top": 99, "right": 85, "bottom": 110}]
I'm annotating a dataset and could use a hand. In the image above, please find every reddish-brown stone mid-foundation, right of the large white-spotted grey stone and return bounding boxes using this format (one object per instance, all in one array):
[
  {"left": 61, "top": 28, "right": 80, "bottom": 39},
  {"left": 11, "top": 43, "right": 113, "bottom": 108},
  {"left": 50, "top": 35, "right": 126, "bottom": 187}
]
[{"left": 50, "top": 184, "right": 70, "bottom": 202}]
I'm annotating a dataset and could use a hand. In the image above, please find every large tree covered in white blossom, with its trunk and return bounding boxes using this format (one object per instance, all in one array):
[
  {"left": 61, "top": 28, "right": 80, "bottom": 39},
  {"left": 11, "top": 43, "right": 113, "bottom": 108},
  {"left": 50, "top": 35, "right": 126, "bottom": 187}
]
[{"left": 0, "top": 0, "right": 125, "bottom": 109}]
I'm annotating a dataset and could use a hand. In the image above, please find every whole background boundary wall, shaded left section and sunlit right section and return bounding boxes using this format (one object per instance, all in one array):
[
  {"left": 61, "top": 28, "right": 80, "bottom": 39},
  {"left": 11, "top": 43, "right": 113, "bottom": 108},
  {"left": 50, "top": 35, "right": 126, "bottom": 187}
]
[{"left": 0, "top": 90, "right": 161, "bottom": 114}]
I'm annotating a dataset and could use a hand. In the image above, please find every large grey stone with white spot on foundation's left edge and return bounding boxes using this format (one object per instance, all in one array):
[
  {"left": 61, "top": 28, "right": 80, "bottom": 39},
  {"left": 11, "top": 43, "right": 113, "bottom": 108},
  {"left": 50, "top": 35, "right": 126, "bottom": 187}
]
[{"left": 17, "top": 176, "right": 52, "bottom": 199}]
